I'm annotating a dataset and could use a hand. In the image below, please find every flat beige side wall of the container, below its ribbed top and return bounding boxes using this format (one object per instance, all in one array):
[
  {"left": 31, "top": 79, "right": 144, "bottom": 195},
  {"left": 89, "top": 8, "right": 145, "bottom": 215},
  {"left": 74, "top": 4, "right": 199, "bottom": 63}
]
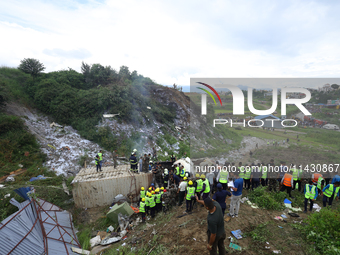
[{"left": 73, "top": 173, "right": 152, "bottom": 208}]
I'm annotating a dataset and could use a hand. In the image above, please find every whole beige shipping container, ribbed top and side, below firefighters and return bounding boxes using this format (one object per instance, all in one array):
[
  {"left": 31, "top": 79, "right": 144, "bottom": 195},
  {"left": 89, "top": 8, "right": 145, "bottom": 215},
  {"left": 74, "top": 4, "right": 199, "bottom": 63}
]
[{"left": 72, "top": 165, "right": 152, "bottom": 208}]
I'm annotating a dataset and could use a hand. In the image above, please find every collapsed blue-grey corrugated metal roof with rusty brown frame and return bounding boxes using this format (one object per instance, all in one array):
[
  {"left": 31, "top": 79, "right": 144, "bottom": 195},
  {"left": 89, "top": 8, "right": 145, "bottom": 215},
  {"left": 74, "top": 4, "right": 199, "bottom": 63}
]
[{"left": 0, "top": 194, "right": 81, "bottom": 255}]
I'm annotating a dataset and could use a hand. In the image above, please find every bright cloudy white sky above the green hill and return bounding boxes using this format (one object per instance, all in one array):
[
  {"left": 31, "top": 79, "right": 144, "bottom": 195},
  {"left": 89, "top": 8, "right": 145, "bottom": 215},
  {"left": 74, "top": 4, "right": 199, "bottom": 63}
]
[{"left": 0, "top": 0, "right": 340, "bottom": 85}]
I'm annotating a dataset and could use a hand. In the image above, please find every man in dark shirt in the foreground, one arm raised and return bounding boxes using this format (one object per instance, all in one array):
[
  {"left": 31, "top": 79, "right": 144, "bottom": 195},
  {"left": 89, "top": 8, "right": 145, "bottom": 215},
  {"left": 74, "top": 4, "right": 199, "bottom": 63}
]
[{"left": 196, "top": 196, "right": 226, "bottom": 255}]
